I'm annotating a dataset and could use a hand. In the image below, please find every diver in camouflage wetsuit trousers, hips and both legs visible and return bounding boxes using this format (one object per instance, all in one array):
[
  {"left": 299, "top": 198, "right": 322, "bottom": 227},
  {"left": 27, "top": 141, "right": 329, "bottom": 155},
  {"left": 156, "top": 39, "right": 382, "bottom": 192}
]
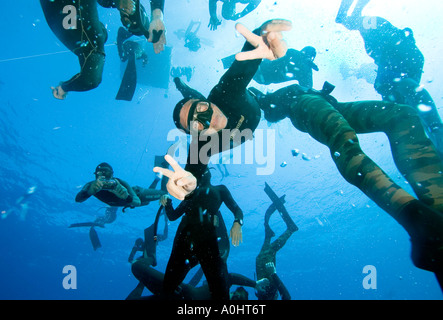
[{"left": 250, "top": 84, "right": 443, "bottom": 286}]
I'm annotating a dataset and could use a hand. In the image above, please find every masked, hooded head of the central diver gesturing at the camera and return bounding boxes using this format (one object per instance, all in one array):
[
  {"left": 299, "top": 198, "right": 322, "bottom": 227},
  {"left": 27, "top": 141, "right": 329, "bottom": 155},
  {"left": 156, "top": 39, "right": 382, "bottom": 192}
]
[{"left": 172, "top": 98, "right": 228, "bottom": 134}]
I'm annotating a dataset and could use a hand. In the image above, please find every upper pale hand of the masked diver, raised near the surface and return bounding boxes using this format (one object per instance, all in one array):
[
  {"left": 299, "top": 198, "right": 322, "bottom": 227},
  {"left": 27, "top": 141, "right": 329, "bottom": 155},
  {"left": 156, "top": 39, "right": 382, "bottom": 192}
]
[{"left": 235, "top": 19, "right": 292, "bottom": 61}]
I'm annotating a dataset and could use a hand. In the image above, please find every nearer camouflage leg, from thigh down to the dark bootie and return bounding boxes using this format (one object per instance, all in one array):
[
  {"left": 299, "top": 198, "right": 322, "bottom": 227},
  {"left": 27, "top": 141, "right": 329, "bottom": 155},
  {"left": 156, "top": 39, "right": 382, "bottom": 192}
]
[{"left": 290, "top": 95, "right": 415, "bottom": 220}]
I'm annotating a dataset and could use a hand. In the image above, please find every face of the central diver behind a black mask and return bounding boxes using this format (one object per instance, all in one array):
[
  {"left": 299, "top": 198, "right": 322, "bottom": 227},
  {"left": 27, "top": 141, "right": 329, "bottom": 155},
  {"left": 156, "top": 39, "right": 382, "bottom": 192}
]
[{"left": 180, "top": 99, "right": 228, "bottom": 135}]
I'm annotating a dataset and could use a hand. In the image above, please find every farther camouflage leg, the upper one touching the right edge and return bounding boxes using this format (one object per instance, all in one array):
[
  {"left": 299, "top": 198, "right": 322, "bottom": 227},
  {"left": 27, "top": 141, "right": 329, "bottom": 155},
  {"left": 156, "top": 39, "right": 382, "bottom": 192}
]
[{"left": 336, "top": 101, "right": 443, "bottom": 211}]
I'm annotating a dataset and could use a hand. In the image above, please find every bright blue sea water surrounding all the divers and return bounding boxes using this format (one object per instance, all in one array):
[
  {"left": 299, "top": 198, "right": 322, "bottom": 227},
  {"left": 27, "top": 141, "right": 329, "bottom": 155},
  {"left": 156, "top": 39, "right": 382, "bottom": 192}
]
[{"left": 0, "top": 0, "right": 443, "bottom": 300}]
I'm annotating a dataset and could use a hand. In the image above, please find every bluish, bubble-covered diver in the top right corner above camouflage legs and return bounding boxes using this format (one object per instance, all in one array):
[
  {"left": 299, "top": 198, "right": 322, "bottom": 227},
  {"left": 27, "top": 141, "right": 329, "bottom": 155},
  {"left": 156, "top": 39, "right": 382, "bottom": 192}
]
[{"left": 335, "top": 0, "right": 443, "bottom": 154}]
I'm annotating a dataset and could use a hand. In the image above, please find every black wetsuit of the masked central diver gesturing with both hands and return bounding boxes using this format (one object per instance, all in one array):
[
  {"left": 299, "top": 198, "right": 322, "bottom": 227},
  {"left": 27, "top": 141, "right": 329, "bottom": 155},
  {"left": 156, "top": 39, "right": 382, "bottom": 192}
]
[{"left": 174, "top": 29, "right": 262, "bottom": 185}]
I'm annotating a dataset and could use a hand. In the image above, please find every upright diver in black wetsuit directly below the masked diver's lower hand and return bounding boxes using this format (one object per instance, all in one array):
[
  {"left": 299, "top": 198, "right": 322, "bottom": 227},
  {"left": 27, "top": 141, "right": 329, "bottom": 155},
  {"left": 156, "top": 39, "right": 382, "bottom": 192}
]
[{"left": 163, "top": 170, "right": 243, "bottom": 300}]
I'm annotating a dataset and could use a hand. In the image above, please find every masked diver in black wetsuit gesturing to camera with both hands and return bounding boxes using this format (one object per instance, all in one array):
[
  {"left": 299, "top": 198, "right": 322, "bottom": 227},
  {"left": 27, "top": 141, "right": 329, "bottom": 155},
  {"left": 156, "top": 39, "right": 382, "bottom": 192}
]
[{"left": 154, "top": 20, "right": 291, "bottom": 200}]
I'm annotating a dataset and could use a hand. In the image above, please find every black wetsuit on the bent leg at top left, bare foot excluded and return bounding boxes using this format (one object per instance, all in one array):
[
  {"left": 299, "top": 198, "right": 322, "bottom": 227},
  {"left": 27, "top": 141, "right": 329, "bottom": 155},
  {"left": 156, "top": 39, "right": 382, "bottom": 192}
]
[{"left": 40, "top": 0, "right": 108, "bottom": 92}]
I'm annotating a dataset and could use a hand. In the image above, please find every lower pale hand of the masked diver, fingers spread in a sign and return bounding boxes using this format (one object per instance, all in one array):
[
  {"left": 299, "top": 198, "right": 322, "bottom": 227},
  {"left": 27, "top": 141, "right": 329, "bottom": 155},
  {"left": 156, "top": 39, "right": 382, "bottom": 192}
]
[{"left": 153, "top": 155, "right": 197, "bottom": 200}]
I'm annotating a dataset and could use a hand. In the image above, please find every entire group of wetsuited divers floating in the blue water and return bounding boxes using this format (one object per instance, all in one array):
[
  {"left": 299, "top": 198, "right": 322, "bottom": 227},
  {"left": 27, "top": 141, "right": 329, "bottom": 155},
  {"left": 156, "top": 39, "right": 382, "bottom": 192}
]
[{"left": 40, "top": 0, "right": 443, "bottom": 300}]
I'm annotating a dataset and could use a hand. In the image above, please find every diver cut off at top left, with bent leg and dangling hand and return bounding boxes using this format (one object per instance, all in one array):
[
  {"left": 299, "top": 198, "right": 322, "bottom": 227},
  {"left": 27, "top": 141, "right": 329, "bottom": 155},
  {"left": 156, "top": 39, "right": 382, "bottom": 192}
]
[{"left": 40, "top": 0, "right": 165, "bottom": 99}]
